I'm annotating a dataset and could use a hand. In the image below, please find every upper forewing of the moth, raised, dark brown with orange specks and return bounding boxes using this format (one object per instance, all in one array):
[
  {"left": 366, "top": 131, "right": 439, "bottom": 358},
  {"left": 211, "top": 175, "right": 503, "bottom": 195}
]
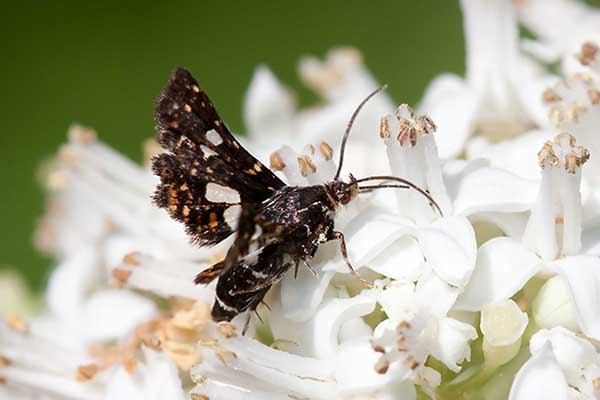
[{"left": 155, "top": 68, "right": 284, "bottom": 200}]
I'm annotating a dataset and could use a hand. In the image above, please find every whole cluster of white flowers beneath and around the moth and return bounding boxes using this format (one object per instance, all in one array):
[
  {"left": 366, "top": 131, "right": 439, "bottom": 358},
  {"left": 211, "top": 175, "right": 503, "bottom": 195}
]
[{"left": 0, "top": 0, "right": 600, "bottom": 400}]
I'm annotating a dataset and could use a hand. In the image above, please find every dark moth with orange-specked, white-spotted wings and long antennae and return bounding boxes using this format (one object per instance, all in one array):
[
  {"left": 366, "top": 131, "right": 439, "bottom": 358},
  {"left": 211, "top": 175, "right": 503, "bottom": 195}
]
[{"left": 152, "top": 68, "right": 441, "bottom": 322}]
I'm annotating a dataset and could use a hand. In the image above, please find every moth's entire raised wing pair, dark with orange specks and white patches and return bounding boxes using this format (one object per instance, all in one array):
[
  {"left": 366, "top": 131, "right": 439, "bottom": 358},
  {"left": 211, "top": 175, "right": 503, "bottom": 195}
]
[{"left": 153, "top": 68, "right": 285, "bottom": 245}]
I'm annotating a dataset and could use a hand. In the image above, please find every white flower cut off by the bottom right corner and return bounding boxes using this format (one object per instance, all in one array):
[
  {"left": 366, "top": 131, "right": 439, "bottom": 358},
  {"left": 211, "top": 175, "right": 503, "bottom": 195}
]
[{"left": 509, "top": 327, "right": 600, "bottom": 400}]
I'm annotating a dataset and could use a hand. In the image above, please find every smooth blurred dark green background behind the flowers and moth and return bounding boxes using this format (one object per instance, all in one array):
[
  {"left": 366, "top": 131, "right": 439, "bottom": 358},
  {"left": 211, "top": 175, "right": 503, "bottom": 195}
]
[{"left": 0, "top": 0, "right": 464, "bottom": 287}]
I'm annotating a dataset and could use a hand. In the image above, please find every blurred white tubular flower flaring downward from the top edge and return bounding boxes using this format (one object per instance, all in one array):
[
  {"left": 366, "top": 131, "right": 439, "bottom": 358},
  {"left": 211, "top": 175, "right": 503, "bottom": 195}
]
[{"left": 421, "top": 0, "right": 547, "bottom": 158}]
